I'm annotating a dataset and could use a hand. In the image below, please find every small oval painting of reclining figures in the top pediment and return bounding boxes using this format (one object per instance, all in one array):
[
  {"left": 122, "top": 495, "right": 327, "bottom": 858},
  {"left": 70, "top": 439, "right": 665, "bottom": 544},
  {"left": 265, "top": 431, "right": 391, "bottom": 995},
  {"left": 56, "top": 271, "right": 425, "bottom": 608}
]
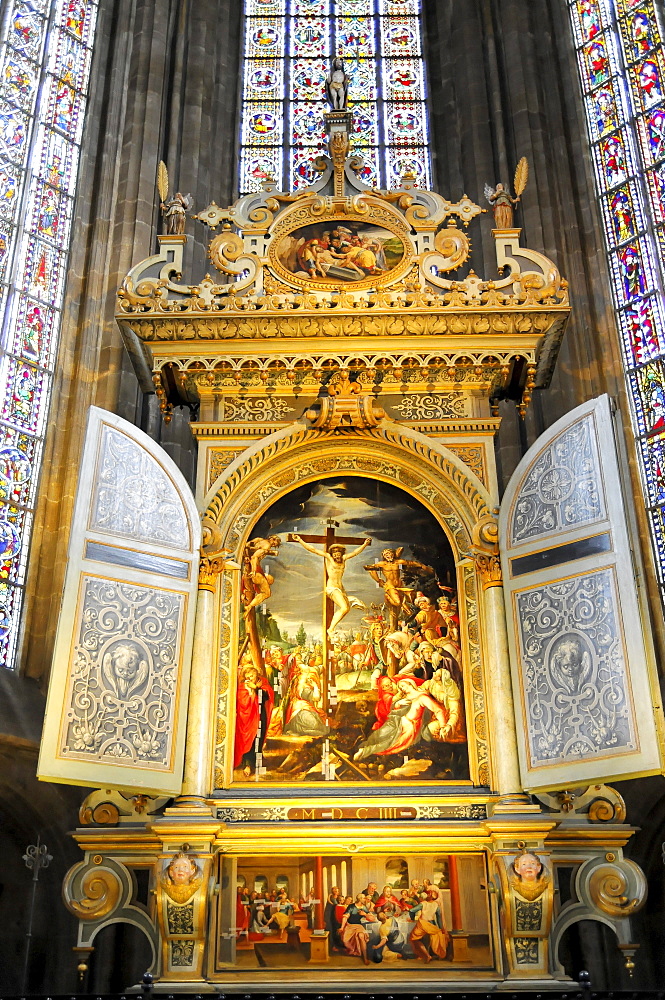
[{"left": 274, "top": 219, "right": 404, "bottom": 284}]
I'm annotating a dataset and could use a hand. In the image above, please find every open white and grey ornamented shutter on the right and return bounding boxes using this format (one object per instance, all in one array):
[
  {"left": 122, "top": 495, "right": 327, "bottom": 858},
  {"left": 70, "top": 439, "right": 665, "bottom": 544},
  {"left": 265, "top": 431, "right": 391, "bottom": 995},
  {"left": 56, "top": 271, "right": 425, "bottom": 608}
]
[{"left": 499, "top": 396, "right": 662, "bottom": 790}]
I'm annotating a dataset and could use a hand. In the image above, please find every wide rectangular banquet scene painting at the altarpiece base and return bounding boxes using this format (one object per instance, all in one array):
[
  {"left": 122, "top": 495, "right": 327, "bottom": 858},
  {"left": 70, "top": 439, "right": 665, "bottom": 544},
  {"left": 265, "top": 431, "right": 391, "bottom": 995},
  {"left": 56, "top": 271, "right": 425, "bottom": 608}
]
[{"left": 217, "top": 854, "right": 494, "bottom": 978}]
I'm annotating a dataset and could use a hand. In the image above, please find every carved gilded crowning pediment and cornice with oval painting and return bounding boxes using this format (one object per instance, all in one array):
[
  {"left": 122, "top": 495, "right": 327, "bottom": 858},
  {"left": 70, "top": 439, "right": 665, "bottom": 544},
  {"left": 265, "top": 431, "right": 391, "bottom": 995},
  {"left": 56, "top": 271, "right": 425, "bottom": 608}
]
[{"left": 117, "top": 142, "right": 569, "bottom": 414}]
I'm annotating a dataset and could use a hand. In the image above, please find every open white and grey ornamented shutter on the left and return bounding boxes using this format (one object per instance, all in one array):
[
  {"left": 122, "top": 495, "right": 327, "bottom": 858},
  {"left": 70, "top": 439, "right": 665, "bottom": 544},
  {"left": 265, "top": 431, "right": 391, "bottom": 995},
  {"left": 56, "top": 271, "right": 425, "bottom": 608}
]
[{"left": 39, "top": 407, "right": 201, "bottom": 794}]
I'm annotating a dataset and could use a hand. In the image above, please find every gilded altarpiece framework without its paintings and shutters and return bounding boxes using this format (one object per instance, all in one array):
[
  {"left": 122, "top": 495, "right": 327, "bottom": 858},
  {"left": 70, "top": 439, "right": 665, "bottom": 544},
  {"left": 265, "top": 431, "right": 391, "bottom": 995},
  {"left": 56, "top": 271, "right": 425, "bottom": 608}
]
[{"left": 49, "top": 127, "right": 656, "bottom": 990}]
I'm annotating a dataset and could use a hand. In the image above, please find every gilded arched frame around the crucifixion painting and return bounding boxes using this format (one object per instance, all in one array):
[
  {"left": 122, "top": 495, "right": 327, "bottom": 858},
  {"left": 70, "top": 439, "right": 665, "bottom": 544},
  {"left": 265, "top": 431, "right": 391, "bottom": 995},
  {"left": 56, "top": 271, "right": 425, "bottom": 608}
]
[{"left": 203, "top": 420, "right": 496, "bottom": 789}]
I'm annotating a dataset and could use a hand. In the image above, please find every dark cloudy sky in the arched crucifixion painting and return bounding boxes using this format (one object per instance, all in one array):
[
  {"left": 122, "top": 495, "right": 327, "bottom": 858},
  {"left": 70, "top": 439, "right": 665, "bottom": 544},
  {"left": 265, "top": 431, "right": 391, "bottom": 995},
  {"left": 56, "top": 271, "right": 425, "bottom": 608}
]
[{"left": 252, "top": 476, "right": 455, "bottom": 638}]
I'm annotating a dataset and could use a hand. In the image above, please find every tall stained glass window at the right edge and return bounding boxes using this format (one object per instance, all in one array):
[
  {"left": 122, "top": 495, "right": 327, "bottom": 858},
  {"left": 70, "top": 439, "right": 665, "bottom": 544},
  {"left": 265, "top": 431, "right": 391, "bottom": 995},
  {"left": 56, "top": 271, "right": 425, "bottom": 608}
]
[{"left": 569, "top": 0, "right": 665, "bottom": 600}]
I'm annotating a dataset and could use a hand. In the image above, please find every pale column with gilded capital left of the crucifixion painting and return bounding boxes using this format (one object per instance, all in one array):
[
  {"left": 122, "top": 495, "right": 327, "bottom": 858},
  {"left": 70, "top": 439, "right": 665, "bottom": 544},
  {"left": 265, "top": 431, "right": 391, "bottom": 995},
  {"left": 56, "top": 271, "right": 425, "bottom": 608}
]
[{"left": 176, "top": 554, "right": 224, "bottom": 807}]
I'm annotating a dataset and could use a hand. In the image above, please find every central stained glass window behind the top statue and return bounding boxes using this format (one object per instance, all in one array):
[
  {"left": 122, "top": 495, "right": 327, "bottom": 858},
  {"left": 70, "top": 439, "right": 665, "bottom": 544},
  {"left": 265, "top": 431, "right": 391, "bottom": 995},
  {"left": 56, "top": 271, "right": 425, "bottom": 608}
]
[{"left": 239, "top": 0, "right": 431, "bottom": 194}]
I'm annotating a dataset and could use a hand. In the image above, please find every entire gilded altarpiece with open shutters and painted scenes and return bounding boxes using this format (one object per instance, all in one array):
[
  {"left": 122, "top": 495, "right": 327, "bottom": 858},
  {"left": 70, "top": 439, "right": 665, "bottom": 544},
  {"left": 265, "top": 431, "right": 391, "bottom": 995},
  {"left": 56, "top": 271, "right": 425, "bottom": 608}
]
[{"left": 41, "top": 121, "right": 661, "bottom": 991}]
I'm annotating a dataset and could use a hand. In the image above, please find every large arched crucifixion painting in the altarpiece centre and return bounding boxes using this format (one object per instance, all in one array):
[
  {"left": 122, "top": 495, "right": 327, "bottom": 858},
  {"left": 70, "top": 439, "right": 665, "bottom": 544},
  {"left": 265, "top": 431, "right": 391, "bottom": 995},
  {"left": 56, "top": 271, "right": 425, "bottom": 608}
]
[{"left": 233, "top": 476, "right": 469, "bottom": 783}]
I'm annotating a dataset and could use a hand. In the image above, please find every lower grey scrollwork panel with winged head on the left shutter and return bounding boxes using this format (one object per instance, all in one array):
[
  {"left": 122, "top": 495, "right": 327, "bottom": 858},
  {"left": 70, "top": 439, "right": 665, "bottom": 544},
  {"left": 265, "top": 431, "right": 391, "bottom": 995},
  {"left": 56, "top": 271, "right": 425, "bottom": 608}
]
[{"left": 60, "top": 576, "right": 185, "bottom": 767}]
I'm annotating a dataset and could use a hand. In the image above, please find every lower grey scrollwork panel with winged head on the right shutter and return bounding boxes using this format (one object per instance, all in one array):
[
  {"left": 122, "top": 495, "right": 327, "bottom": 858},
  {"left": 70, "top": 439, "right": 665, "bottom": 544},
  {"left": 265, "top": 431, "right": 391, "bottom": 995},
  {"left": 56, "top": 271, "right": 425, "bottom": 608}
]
[{"left": 516, "top": 569, "right": 637, "bottom": 767}]
